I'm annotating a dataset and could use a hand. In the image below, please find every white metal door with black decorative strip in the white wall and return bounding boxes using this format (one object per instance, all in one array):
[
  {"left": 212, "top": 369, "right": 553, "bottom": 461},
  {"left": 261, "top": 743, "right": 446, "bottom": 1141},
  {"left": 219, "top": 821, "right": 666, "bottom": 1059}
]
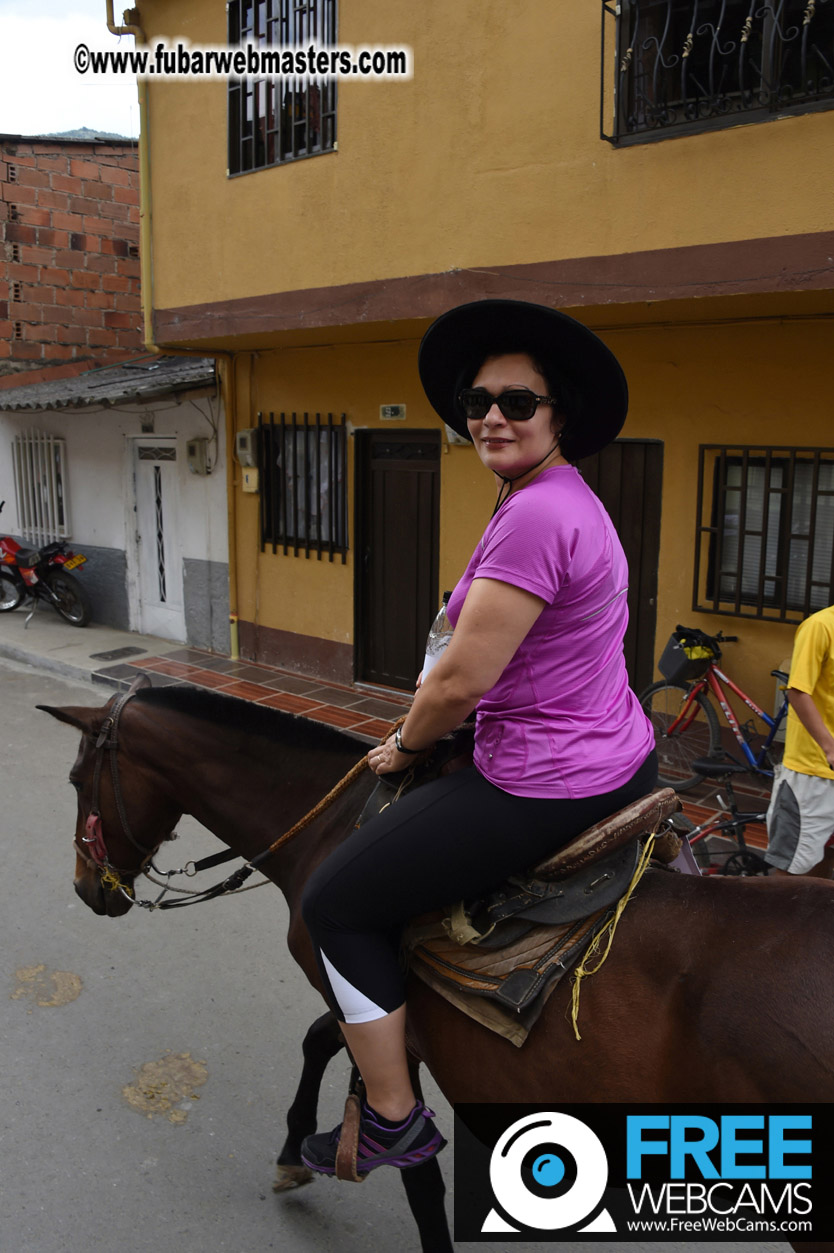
[{"left": 134, "top": 435, "right": 185, "bottom": 640}]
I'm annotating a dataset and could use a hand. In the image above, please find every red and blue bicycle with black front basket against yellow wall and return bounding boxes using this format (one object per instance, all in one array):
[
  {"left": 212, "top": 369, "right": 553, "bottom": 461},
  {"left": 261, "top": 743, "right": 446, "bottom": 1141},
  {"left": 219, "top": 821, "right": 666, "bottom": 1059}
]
[{"left": 639, "top": 627, "right": 788, "bottom": 792}]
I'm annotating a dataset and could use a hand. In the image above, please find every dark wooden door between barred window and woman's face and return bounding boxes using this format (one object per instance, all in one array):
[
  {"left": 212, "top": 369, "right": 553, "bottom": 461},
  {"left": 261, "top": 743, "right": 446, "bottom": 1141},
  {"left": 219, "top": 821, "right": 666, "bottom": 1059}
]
[{"left": 356, "top": 430, "right": 441, "bottom": 692}]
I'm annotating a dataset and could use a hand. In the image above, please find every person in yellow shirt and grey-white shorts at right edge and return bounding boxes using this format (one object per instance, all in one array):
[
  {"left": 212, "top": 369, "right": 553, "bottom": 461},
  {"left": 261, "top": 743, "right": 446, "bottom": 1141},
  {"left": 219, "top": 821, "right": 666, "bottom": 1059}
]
[{"left": 765, "top": 605, "right": 834, "bottom": 878}]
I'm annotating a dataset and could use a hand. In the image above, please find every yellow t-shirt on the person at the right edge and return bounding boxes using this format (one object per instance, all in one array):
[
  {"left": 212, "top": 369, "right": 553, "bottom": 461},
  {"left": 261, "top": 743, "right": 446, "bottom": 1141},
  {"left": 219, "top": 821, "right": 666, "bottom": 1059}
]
[{"left": 784, "top": 605, "right": 834, "bottom": 779}]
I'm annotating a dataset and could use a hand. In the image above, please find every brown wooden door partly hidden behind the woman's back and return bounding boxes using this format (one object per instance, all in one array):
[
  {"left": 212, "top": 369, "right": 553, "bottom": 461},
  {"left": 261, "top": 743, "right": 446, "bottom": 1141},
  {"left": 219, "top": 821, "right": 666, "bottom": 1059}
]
[{"left": 579, "top": 440, "right": 664, "bottom": 692}]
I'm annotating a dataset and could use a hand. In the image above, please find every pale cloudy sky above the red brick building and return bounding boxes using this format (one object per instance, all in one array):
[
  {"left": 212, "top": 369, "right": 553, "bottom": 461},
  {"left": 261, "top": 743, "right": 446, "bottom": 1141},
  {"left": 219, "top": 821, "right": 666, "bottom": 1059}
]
[{"left": 0, "top": 0, "right": 139, "bottom": 137}]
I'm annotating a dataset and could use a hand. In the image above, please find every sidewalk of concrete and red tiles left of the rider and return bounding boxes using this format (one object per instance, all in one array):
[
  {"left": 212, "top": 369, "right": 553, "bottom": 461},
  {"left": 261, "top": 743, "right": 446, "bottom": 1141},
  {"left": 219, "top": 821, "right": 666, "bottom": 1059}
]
[{"left": 0, "top": 604, "right": 411, "bottom": 743}]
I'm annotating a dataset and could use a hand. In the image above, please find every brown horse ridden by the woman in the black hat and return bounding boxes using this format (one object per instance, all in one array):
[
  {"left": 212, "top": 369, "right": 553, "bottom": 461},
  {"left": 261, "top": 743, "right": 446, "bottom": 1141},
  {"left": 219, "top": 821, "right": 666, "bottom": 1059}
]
[{"left": 41, "top": 684, "right": 834, "bottom": 1247}]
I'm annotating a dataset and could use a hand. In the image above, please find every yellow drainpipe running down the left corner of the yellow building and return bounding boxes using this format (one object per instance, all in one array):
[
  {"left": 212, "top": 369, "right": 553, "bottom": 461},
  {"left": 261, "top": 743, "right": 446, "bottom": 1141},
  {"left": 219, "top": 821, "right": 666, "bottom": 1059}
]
[{"left": 105, "top": 9, "right": 240, "bottom": 662}]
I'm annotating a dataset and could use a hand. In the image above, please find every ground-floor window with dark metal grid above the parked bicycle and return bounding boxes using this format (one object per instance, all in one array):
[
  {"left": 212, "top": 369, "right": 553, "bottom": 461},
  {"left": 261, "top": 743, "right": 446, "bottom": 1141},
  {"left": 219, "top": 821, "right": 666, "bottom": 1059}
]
[{"left": 692, "top": 445, "right": 834, "bottom": 621}]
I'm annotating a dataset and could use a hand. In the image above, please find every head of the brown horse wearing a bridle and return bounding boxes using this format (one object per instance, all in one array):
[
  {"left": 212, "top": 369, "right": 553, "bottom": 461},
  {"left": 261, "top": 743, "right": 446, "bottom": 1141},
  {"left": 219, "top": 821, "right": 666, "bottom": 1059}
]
[{"left": 38, "top": 674, "right": 180, "bottom": 917}]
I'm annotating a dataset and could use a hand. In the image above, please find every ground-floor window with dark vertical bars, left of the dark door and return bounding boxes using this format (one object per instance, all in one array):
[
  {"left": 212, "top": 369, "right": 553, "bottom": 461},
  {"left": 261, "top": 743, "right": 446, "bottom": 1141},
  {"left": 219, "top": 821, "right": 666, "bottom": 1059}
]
[{"left": 258, "top": 413, "right": 348, "bottom": 564}]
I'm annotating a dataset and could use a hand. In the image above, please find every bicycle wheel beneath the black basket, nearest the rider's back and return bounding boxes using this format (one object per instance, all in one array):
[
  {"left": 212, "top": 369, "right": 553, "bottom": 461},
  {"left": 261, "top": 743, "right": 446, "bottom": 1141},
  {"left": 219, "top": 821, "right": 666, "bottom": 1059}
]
[{"left": 639, "top": 679, "right": 721, "bottom": 792}]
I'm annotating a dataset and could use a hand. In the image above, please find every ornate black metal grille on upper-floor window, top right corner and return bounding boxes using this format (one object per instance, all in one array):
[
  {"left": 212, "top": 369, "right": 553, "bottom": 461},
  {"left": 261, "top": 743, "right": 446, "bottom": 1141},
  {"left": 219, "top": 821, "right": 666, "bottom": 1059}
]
[{"left": 601, "top": 0, "right": 834, "bottom": 143}]
